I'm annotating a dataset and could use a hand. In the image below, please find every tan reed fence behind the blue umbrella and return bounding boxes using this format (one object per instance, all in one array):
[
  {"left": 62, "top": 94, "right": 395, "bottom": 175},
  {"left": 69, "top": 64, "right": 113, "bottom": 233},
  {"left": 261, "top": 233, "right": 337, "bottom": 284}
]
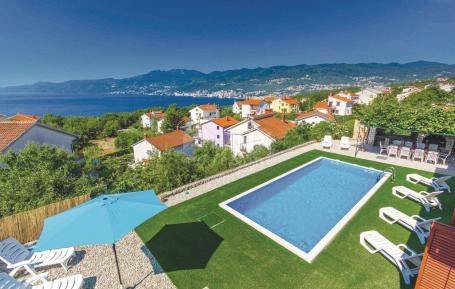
[{"left": 0, "top": 194, "right": 90, "bottom": 243}]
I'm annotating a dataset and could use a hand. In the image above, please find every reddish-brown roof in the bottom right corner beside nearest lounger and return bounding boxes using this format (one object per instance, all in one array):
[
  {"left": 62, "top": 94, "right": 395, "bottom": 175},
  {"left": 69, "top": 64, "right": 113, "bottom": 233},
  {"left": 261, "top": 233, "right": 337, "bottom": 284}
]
[{"left": 415, "top": 222, "right": 455, "bottom": 289}]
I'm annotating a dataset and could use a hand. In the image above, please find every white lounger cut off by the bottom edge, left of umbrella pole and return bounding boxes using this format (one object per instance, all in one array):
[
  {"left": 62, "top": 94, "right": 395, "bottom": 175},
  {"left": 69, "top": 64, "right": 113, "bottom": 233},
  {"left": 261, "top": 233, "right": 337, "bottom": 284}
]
[{"left": 0, "top": 273, "right": 84, "bottom": 289}]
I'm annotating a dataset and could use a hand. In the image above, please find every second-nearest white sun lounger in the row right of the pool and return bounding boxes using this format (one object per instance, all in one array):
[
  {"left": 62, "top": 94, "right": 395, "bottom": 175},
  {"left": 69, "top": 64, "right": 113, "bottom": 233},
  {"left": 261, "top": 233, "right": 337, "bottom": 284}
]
[{"left": 379, "top": 207, "right": 440, "bottom": 244}]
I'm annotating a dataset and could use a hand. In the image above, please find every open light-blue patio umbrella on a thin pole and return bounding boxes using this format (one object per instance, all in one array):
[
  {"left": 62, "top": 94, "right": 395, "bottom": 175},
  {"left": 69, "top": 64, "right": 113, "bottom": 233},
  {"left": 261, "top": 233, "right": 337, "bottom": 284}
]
[{"left": 34, "top": 190, "right": 166, "bottom": 285}]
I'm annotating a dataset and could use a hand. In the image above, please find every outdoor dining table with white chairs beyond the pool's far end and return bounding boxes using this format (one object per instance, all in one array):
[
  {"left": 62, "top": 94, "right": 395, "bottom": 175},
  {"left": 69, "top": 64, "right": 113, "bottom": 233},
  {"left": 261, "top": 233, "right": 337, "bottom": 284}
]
[{"left": 379, "top": 138, "right": 451, "bottom": 165}]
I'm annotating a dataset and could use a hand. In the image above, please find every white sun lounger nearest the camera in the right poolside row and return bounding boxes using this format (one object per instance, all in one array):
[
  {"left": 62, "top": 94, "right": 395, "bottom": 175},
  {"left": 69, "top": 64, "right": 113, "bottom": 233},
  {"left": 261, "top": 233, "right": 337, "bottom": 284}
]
[{"left": 360, "top": 231, "right": 423, "bottom": 285}]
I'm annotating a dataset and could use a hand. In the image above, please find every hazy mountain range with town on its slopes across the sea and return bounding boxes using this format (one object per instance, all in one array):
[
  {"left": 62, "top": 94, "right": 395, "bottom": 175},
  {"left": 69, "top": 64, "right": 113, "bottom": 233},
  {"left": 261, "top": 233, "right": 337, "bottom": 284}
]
[{"left": 0, "top": 61, "right": 455, "bottom": 97}]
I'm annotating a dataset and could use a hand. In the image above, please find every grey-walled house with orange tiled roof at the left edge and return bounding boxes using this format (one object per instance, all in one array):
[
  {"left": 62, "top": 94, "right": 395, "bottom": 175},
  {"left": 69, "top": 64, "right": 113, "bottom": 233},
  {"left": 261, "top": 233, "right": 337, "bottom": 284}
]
[{"left": 0, "top": 114, "right": 78, "bottom": 153}]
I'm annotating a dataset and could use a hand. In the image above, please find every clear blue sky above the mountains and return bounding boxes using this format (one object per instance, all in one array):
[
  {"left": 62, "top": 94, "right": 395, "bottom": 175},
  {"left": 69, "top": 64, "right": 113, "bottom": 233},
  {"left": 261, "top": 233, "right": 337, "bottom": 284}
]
[{"left": 0, "top": 0, "right": 455, "bottom": 86}]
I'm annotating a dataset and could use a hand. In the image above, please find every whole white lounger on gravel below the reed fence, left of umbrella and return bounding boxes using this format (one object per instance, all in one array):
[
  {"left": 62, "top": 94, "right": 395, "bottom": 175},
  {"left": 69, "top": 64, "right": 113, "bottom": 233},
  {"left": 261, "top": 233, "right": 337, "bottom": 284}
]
[{"left": 0, "top": 238, "right": 74, "bottom": 276}]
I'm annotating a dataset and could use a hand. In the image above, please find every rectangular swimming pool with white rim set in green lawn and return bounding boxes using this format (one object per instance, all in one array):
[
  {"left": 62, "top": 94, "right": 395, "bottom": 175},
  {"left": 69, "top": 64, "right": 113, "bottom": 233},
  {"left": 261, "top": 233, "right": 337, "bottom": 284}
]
[{"left": 220, "top": 157, "right": 390, "bottom": 263}]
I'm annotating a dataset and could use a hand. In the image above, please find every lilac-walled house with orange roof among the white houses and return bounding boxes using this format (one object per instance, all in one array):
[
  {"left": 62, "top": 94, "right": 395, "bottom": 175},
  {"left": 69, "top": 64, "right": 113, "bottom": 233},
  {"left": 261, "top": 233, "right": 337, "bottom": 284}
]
[{"left": 199, "top": 116, "right": 239, "bottom": 147}]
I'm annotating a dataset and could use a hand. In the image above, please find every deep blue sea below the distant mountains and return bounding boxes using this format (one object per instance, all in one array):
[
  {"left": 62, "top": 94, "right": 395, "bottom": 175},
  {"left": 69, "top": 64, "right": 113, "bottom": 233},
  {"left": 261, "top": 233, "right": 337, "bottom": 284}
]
[{"left": 0, "top": 94, "right": 242, "bottom": 116}]
